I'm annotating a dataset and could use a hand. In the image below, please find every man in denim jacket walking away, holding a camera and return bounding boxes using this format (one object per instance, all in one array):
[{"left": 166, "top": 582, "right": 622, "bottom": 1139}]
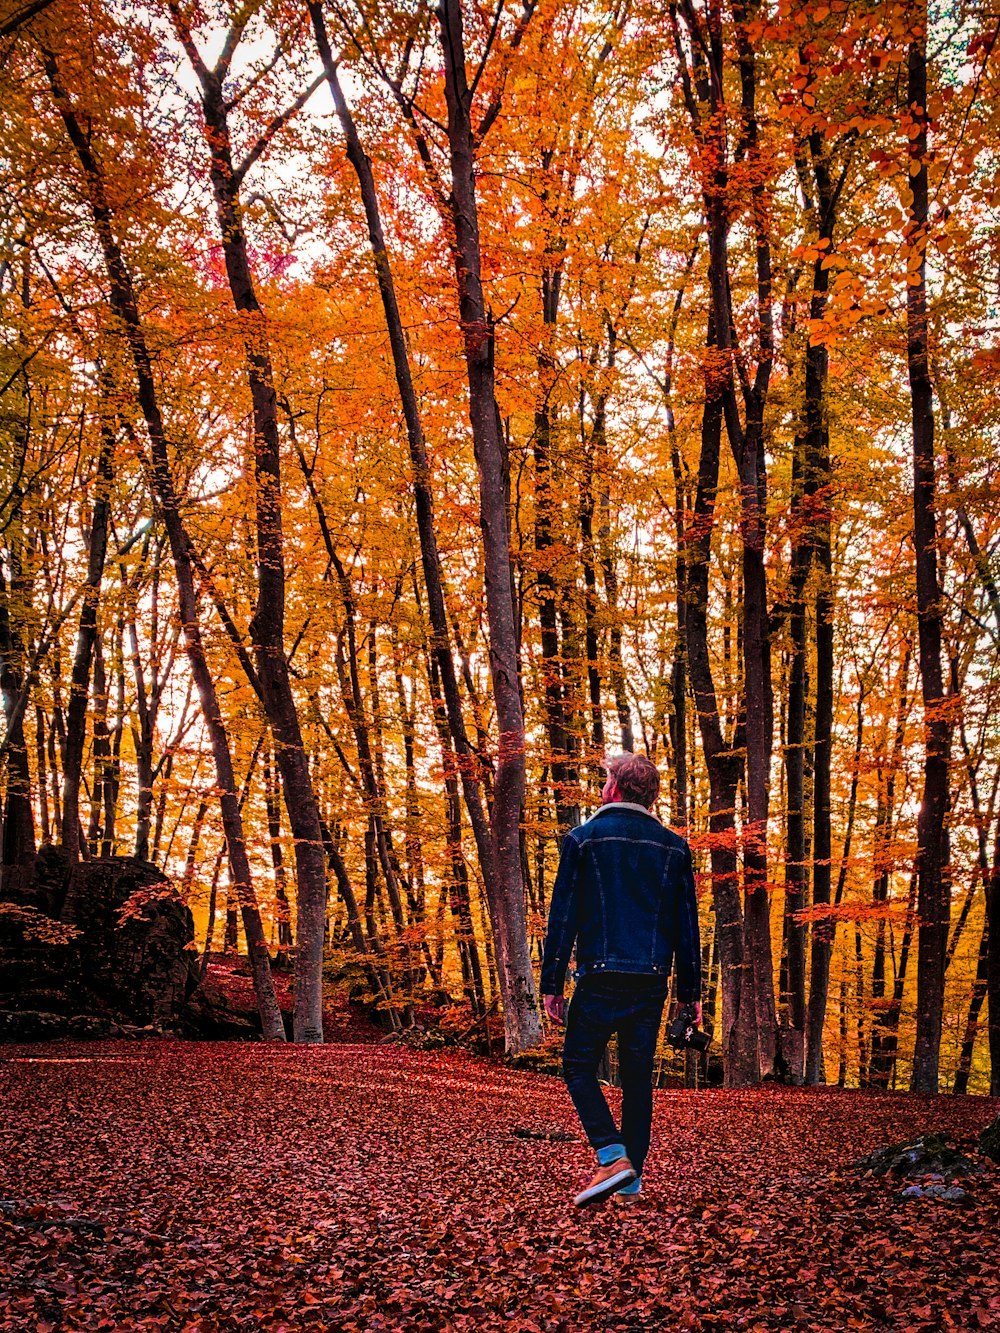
[{"left": 541, "top": 754, "right": 701, "bottom": 1205}]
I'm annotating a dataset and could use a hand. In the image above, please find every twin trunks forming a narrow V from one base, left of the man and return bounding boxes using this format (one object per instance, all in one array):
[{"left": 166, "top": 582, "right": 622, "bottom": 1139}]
[{"left": 309, "top": 4, "right": 541, "bottom": 1052}]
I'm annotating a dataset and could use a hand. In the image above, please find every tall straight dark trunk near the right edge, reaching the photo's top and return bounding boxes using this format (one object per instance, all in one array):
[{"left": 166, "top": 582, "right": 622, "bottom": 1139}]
[{"left": 907, "top": 25, "right": 951, "bottom": 1093}]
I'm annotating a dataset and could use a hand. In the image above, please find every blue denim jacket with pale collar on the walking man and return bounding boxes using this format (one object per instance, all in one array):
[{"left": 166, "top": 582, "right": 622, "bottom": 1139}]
[{"left": 541, "top": 801, "right": 701, "bottom": 1004}]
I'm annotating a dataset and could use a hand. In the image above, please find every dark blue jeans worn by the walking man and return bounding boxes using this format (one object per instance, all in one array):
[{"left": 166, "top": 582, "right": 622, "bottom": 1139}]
[{"left": 563, "top": 972, "right": 667, "bottom": 1174}]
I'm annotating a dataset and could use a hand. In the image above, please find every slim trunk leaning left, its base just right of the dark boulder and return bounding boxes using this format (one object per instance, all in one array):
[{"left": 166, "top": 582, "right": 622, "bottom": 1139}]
[{"left": 44, "top": 52, "right": 285, "bottom": 1041}]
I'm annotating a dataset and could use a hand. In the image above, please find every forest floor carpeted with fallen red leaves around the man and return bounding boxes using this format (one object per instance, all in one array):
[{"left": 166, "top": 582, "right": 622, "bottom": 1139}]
[{"left": 0, "top": 1040, "right": 1000, "bottom": 1333}]
